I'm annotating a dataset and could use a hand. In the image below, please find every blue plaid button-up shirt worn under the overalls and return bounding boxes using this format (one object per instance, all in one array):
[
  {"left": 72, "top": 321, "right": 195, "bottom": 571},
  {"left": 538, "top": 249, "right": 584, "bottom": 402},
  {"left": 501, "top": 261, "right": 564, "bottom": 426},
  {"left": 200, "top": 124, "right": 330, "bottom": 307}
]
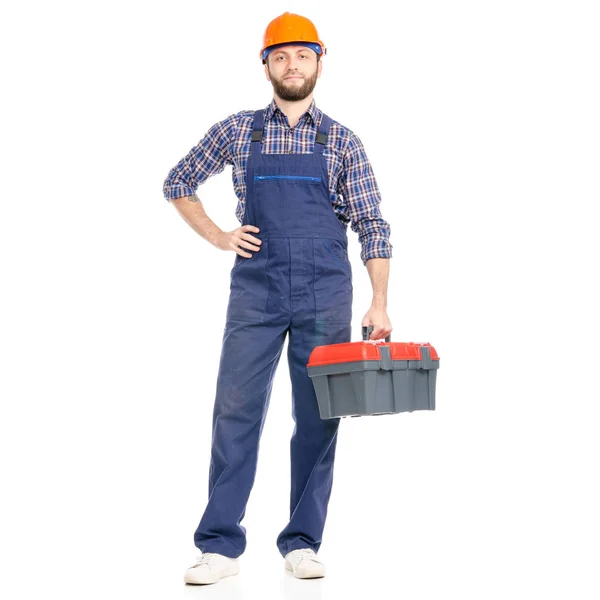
[{"left": 163, "top": 100, "right": 392, "bottom": 263}]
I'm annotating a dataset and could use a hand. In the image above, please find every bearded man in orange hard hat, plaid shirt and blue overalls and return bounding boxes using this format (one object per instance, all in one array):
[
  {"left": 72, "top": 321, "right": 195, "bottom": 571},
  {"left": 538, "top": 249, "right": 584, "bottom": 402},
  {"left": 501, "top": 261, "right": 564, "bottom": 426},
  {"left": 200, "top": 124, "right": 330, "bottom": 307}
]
[{"left": 164, "top": 13, "right": 392, "bottom": 584}]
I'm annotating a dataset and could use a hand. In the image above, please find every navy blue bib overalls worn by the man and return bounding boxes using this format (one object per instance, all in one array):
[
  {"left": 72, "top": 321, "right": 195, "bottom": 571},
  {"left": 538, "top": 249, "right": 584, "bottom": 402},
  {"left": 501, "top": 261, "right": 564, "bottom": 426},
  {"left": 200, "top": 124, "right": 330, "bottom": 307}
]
[{"left": 194, "top": 110, "right": 352, "bottom": 558}]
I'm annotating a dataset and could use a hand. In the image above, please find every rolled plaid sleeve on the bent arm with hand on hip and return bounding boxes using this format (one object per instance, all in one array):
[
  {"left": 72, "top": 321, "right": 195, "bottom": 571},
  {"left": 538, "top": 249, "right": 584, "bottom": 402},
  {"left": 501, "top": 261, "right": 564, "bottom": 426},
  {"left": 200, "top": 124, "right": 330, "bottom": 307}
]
[{"left": 163, "top": 115, "right": 237, "bottom": 200}]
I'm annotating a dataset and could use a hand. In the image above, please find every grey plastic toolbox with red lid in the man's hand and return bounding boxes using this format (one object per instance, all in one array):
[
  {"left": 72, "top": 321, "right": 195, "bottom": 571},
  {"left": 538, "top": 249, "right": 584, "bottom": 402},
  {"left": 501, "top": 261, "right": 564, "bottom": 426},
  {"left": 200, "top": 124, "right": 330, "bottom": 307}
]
[{"left": 307, "top": 327, "right": 440, "bottom": 419}]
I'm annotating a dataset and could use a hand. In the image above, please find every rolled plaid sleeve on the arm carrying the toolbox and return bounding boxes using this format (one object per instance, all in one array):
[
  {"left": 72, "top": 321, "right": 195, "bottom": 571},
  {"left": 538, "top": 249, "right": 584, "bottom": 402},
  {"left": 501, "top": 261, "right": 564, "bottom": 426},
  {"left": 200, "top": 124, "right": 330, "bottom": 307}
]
[{"left": 338, "top": 133, "right": 392, "bottom": 263}]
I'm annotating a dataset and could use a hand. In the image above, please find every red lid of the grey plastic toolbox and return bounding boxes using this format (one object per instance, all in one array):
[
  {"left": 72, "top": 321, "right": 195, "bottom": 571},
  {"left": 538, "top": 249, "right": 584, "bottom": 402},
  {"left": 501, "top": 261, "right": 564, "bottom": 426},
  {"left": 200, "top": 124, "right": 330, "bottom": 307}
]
[{"left": 307, "top": 342, "right": 439, "bottom": 367}]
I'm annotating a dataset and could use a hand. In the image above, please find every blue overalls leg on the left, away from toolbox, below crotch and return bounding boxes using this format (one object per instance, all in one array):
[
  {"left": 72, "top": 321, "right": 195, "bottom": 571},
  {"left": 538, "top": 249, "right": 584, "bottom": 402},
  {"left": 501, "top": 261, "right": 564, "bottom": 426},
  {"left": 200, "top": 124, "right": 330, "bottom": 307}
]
[{"left": 194, "top": 321, "right": 287, "bottom": 558}]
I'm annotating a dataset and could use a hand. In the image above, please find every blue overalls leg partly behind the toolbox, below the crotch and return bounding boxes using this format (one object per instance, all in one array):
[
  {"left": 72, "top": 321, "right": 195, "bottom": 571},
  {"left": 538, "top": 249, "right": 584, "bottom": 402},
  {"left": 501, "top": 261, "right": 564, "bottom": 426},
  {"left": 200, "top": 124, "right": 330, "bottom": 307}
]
[{"left": 277, "top": 321, "right": 351, "bottom": 556}]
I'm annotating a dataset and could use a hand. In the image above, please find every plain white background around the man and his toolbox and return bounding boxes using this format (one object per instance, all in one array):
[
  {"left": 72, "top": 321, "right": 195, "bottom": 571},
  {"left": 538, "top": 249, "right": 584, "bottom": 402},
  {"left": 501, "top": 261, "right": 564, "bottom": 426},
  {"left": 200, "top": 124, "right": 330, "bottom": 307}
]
[{"left": 0, "top": 0, "right": 600, "bottom": 599}]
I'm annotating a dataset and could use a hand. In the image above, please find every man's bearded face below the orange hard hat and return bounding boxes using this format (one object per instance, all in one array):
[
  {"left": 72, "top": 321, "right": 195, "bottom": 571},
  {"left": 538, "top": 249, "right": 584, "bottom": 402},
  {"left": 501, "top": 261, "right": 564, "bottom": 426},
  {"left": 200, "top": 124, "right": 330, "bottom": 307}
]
[{"left": 265, "top": 46, "right": 322, "bottom": 102}]
